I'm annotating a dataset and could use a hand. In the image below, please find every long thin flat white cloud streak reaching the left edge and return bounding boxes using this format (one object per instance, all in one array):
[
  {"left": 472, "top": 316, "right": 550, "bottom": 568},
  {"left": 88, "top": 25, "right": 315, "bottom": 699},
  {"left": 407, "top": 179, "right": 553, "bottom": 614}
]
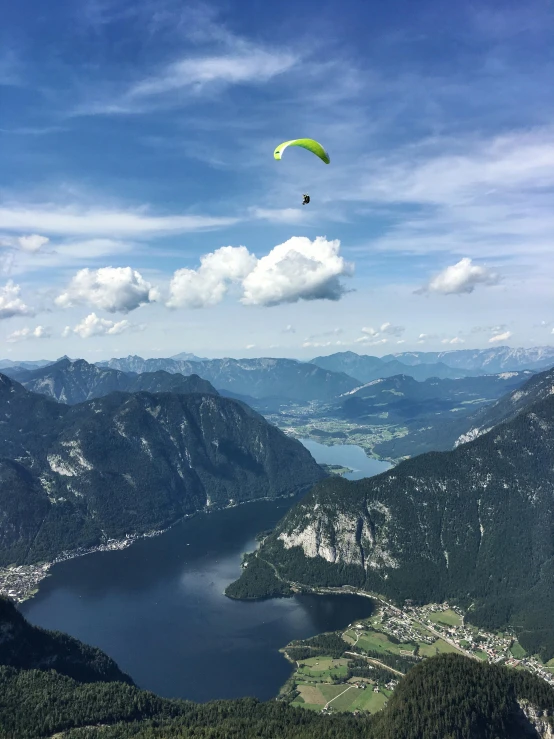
[{"left": 0, "top": 204, "right": 238, "bottom": 237}]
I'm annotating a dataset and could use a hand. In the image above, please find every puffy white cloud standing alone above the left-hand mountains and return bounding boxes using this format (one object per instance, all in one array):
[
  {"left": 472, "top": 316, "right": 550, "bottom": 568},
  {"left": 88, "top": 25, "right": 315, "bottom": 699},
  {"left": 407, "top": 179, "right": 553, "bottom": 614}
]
[{"left": 55, "top": 267, "right": 159, "bottom": 313}]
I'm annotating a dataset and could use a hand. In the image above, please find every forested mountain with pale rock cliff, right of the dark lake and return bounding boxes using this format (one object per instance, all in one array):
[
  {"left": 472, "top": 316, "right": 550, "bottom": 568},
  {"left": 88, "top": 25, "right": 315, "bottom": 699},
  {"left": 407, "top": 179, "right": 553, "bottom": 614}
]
[{"left": 236, "top": 388, "right": 554, "bottom": 659}]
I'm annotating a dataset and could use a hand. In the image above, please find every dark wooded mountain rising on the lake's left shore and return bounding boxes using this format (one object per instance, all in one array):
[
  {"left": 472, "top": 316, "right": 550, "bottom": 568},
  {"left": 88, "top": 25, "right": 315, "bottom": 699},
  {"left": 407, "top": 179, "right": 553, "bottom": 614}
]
[{"left": 0, "top": 374, "right": 324, "bottom": 564}]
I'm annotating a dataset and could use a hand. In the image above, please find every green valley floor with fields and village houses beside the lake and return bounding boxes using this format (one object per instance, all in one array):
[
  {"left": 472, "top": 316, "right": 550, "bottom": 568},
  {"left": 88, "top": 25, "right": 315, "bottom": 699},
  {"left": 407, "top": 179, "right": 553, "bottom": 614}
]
[{"left": 280, "top": 588, "right": 554, "bottom": 713}]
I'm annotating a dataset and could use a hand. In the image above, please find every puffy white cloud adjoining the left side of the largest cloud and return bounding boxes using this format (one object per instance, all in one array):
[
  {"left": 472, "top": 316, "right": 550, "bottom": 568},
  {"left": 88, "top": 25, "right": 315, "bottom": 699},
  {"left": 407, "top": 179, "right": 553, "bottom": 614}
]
[{"left": 167, "top": 246, "right": 257, "bottom": 308}]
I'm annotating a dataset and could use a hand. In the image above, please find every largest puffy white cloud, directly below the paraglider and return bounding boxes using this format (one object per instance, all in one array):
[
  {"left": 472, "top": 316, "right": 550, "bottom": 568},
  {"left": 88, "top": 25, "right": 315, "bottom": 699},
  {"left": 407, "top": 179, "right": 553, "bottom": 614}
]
[{"left": 241, "top": 236, "right": 353, "bottom": 306}]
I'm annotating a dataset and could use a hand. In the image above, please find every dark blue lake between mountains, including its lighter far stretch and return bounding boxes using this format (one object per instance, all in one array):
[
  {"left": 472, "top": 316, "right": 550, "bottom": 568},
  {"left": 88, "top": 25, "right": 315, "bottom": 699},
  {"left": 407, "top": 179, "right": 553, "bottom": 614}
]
[{"left": 21, "top": 441, "right": 386, "bottom": 701}]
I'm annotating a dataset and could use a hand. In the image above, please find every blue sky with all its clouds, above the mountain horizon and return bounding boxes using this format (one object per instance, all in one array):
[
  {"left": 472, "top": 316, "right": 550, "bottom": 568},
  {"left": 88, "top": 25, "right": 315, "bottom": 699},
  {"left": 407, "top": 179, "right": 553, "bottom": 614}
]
[{"left": 0, "top": 0, "right": 554, "bottom": 360}]
